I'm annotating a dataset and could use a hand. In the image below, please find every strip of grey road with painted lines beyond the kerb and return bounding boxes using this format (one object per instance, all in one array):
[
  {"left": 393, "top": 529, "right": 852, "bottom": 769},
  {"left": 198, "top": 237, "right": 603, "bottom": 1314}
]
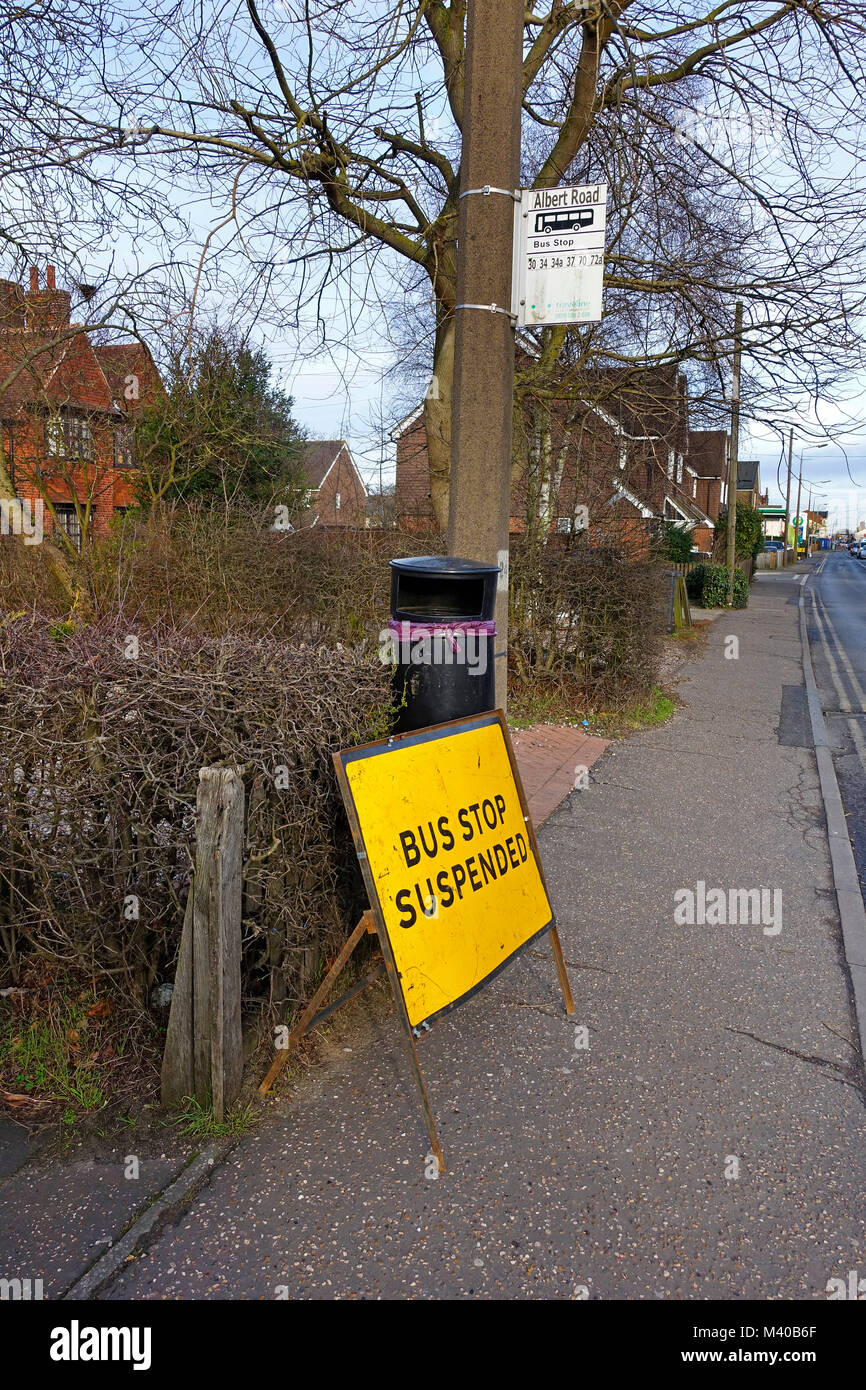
[{"left": 805, "top": 550, "right": 866, "bottom": 890}]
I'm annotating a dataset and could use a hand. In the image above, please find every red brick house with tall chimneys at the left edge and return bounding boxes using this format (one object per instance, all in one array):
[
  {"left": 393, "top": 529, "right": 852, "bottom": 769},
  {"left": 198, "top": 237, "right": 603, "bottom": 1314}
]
[{"left": 0, "top": 265, "right": 161, "bottom": 549}]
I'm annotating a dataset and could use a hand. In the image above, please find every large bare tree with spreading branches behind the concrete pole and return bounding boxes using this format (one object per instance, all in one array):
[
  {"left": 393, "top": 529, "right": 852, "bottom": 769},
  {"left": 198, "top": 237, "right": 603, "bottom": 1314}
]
[{"left": 1, "top": 0, "right": 866, "bottom": 523}]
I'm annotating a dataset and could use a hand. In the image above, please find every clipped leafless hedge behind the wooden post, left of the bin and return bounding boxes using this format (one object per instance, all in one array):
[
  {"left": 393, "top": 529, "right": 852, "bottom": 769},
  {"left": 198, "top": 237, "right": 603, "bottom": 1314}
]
[{"left": 0, "top": 616, "right": 389, "bottom": 1002}]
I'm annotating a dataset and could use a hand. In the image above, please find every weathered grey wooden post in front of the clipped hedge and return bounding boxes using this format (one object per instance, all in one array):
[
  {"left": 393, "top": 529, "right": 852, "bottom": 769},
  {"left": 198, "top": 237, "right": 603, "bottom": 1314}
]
[{"left": 161, "top": 767, "right": 243, "bottom": 1120}]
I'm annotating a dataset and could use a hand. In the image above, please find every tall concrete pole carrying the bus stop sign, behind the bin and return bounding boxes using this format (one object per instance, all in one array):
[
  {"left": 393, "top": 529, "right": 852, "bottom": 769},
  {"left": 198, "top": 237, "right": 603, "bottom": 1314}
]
[{"left": 448, "top": 0, "right": 525, "bottom": 709}]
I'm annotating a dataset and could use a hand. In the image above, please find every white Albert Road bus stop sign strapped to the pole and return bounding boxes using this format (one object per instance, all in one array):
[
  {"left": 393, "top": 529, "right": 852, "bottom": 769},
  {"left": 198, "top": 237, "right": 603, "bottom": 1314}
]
[{"left": 512, "top": 183, "right": 607, "bottom": 328}]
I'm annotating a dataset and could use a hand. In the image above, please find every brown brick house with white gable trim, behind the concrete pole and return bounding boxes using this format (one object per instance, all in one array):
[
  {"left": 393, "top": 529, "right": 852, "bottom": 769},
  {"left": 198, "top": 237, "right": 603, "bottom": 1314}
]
[{"left": 391, "top": 367, "right": 719, "bottom": 550}]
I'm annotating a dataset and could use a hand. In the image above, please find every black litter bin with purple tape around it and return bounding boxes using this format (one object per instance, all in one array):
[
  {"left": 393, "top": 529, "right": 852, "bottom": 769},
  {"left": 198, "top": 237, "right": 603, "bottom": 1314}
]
[{"left": 388, "top": 555, "right": 499, "bottom": 733}]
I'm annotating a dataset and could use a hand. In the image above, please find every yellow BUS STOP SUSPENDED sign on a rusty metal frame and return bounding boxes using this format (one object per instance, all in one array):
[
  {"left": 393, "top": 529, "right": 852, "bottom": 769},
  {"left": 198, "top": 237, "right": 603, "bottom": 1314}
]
[{"left": 334, "top": 710, "right": 574, "bottom": 1167}]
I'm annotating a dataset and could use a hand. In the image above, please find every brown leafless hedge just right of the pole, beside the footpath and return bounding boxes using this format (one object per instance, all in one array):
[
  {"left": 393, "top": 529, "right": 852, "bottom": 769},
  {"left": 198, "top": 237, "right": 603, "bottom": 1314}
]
[{"left": 509, "top": 541, "right": 667, "bottom": 710}]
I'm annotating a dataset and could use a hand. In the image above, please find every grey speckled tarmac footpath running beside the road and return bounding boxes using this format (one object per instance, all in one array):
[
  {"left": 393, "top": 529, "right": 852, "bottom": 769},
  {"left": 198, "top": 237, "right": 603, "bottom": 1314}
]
[{"left": 62, "top": 575, "right": 866, "bottom": 1300}]
